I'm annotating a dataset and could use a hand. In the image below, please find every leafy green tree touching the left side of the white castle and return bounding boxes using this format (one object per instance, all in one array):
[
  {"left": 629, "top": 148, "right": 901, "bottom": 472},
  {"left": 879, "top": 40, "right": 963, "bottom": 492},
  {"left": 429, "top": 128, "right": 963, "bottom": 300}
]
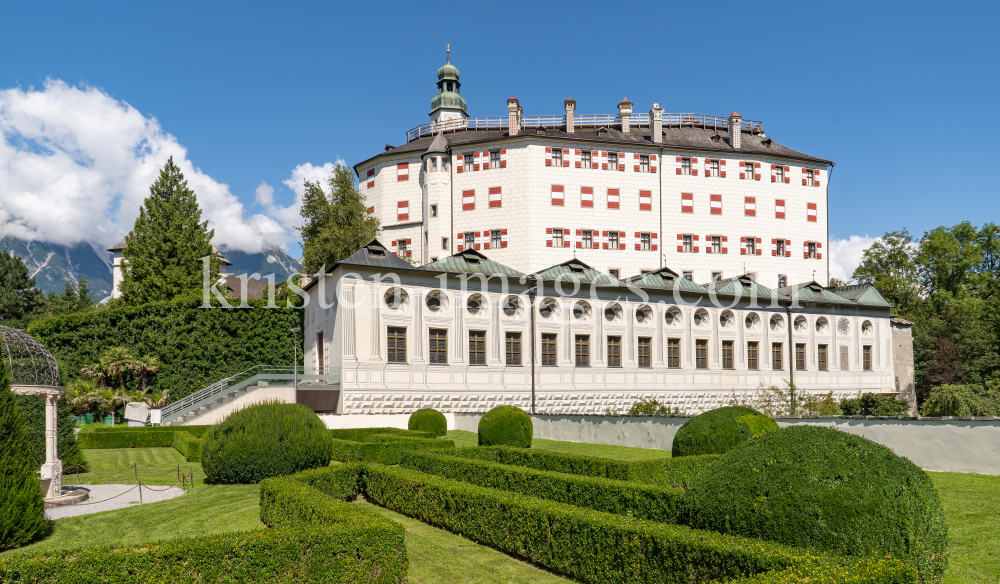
[{"left": 298, "top": 166, "right": 381, "bottom": 273}]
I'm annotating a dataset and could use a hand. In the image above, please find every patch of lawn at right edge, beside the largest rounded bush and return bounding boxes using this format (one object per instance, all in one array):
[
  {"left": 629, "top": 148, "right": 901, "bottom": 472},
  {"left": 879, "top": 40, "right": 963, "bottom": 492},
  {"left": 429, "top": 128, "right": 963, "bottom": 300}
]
[{"left": 927, "top": 472, "right": 1000, "bottom": 584}]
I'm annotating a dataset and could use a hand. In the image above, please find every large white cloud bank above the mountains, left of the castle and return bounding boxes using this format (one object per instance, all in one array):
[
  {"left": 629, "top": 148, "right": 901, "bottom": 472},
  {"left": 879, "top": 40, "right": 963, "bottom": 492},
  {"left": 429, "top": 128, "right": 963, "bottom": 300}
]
[{"left": 0, "top": 79, "right": 342, "bottom": 253}]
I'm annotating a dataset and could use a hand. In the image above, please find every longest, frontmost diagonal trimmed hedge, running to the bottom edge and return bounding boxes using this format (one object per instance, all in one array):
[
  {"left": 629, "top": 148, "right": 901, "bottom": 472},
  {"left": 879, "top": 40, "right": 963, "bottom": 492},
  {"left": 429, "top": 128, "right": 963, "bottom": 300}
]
[{"left": 365, "top": 464, "right": 916, "bottom": 584}]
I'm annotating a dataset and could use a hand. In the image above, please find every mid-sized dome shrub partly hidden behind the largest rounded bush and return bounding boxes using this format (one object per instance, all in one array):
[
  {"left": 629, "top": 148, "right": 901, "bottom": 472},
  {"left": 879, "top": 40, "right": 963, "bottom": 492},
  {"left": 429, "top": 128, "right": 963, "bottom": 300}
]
[{"left": 671, "top": 406, "right": 778, "bottom": 457}]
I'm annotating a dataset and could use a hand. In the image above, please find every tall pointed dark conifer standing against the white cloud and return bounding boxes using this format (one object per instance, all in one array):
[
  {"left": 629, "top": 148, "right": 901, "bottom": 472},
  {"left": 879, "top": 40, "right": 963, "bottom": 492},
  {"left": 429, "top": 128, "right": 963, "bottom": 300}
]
[{"left": 121, "top": 157, "right": 219, "bottom": 306}]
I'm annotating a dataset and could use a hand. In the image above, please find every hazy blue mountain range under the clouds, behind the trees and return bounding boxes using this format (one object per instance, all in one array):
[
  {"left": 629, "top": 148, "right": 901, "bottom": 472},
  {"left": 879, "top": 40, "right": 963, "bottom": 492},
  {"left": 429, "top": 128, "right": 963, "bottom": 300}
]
[{"left": 0, "top": 236, "right": 302, "bottom": 301}]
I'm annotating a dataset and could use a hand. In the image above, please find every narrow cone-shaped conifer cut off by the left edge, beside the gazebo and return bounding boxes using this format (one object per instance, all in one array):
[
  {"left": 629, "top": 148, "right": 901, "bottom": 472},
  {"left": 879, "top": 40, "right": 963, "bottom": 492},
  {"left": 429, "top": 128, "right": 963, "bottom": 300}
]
[{"left": 0, "top": 361, "right": 49, "bottom": 551}]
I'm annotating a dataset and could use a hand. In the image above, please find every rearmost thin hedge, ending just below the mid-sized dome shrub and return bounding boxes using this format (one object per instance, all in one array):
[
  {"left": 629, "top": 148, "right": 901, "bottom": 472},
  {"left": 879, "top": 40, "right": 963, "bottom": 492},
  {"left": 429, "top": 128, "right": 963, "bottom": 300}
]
[{"left": 453, "top": 446, "right": 718, "bottom": 487}]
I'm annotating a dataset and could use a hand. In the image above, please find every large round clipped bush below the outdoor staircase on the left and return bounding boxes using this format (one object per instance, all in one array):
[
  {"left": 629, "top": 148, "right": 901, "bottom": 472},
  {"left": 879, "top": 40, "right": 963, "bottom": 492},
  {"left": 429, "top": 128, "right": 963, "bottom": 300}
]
[{"left": 201, "top": 402, "right": 333, "bottom": 484}]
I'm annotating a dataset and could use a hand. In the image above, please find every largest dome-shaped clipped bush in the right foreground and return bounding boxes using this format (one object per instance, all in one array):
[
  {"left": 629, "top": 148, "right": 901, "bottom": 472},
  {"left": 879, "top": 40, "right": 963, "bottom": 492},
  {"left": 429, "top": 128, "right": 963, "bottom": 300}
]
[{"left": 681, "top": 426, "right": 948, "bottom": 582}]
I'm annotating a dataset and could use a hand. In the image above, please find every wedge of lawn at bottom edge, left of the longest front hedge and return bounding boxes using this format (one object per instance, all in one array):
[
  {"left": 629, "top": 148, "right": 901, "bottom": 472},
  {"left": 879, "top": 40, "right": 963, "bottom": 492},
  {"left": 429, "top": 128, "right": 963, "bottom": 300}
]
[{"left": 358, "top": 502, "right": 573, "bottom": 584}]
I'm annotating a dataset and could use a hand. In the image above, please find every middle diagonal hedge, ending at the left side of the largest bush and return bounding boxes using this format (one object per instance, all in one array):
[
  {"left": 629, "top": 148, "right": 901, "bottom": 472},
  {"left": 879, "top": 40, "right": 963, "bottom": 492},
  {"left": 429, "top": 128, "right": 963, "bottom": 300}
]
[{"left": 399, "top": 451, "right": 684, "bottom": 523}]
